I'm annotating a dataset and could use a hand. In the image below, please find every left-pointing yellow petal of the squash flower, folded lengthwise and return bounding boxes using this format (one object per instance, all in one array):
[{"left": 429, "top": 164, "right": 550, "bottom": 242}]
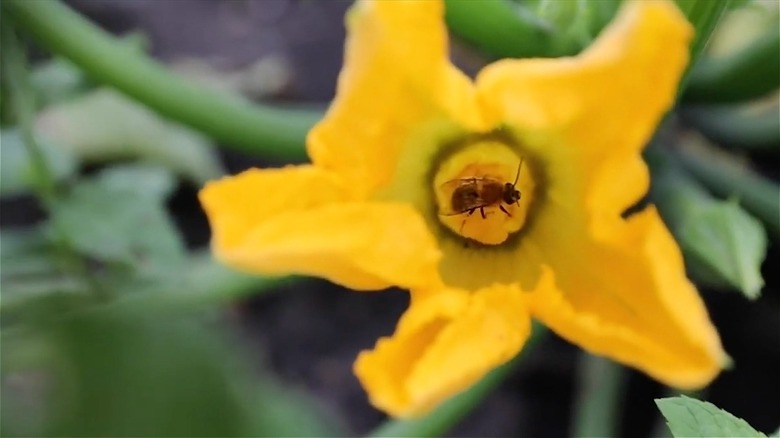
[{"left": 200, "top": 166, "right": 440, "bottom": 290}]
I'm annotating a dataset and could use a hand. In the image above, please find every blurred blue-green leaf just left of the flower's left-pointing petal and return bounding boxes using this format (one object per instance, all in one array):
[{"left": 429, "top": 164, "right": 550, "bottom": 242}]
[{"left": 51, "top": 171, "right": 184, "bottom": 273}]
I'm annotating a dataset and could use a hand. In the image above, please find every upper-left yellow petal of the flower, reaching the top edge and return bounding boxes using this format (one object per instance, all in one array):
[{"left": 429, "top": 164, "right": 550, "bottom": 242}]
[{"left": 307, "top": 0, "right": 481, "bottom": 197}]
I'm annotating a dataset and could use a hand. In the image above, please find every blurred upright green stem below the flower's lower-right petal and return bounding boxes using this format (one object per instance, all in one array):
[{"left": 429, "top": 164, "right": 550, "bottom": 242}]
[{"left": 573, "top": 351, "right": 626, "bottom": 438}]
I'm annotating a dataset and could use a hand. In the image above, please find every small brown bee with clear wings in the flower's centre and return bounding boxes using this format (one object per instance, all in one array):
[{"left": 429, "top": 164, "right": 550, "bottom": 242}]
[{"left": 439, "top": 159, "right": 523, "bottom": 231}]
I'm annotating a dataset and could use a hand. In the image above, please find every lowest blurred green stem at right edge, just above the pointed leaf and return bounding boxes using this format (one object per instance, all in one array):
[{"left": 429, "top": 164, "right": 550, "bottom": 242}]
[{"left": 677, "top": 140, "right": 780, "bottom": 239}]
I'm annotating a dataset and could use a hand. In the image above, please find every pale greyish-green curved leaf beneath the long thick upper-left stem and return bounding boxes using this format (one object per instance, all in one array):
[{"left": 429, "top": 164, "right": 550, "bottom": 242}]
[{"left": 36, "top": 89, "right": 224, "bottom": 185}]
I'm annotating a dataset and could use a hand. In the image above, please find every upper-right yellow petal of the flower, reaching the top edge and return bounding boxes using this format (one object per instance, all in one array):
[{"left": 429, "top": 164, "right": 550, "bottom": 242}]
[{"left": 477, "top": 0, "right": 693, "bottom": 216}]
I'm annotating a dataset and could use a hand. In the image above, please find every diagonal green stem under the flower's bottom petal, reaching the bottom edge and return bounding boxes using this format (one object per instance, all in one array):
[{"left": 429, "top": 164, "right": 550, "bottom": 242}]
[{"left": 369, "top": 323, "right": 547, "bottom": 437}]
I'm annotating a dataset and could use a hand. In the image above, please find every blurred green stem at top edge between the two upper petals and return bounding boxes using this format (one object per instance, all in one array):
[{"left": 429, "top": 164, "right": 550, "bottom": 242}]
[{"left": 445, "top": 0, "right": 579, "bottom": 58}]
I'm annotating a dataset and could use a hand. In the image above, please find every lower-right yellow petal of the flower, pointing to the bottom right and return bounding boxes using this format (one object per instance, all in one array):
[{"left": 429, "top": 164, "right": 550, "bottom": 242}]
[{"left": 529, "top": 207, "right": 727, "bottom": 389}]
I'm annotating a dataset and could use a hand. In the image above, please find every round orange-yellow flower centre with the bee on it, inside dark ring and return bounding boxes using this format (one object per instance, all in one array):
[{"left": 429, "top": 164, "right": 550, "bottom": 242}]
[{"left": 433, "top": 140, "right": 535, "bottom": 245}]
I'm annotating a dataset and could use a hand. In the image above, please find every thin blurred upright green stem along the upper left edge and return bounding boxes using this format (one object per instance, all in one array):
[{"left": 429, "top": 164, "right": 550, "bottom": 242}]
[{"left": 0, "top": 17, "right": 56, "bottom": 208}]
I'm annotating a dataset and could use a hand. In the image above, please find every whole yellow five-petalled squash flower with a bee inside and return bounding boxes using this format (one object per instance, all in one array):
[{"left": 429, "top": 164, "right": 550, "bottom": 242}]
[{"left": 200, "top": 0, "right": 726, "bottom": 417}]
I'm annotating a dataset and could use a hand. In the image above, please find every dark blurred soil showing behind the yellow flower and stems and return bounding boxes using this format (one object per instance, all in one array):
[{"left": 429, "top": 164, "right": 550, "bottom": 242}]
[{"left": 10, "top": 0, "right": 780, "bottom": 437}]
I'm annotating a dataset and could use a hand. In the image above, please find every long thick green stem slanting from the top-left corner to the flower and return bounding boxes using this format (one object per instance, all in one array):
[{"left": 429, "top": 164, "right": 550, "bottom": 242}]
[{"left": 2, "top": 0, "right": 321, "bottom": 160}]
